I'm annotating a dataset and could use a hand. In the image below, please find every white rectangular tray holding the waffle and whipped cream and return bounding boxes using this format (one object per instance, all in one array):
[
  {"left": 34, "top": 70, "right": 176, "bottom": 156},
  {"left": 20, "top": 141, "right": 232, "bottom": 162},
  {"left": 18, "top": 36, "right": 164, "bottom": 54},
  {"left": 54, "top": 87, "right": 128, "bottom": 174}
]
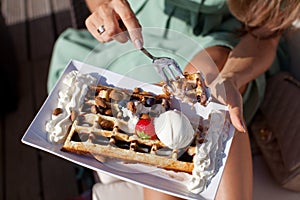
[{"left": 22, "top": 60, "right": 234, "bottom": 199}]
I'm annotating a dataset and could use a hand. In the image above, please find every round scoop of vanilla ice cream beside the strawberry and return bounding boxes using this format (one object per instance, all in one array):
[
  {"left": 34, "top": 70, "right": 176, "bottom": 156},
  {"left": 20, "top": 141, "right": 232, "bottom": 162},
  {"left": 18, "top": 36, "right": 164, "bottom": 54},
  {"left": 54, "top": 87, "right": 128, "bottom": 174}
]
[{"left": 154, "top": 110, "right": 195, "bottom": 149}]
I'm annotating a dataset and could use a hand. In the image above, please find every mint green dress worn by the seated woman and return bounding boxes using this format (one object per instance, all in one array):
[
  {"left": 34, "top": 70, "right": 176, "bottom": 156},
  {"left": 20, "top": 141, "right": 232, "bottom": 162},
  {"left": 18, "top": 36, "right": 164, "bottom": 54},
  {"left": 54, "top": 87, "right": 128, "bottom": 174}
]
[{"left": 48, "top": 0, "right": 286, "bottom": 124}]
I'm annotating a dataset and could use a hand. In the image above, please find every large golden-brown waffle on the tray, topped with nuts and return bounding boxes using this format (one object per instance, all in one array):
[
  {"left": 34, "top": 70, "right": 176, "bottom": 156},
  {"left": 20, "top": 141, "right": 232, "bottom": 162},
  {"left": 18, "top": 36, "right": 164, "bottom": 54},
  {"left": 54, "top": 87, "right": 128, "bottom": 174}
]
[{"left": 62, "top": 85, "right": 203, "bottom": 173}]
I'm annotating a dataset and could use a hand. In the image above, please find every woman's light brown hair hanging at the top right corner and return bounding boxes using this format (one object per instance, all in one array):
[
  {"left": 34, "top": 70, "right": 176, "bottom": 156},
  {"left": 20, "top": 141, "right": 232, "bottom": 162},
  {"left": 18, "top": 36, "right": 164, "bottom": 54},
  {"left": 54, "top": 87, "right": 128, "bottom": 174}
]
[{"left": 228, "top": 0, "right": 300, "bottom": 38}]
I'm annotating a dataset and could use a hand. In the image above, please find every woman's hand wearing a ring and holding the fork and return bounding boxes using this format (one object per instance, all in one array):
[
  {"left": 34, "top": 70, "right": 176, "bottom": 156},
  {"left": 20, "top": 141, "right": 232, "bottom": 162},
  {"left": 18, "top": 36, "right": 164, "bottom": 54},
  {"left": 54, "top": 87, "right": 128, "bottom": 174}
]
[{"left": 85, "top": 0, "right": 143, "bottom": 49}]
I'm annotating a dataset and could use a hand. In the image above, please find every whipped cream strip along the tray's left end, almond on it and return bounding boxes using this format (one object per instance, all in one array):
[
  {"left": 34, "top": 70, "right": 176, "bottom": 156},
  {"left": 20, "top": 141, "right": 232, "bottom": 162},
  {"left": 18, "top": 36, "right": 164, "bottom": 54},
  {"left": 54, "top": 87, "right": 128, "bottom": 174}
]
[{"left": 46, "top": 71, "right": 96, "bottom": 143}]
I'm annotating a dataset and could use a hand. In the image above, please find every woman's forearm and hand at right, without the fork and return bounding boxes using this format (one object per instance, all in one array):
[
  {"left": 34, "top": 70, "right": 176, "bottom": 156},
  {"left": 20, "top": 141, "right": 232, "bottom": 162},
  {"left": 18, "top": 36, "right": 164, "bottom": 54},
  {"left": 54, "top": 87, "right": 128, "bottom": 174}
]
[{"left": 209, "top": 34, "right": 280, "bottom": 132}]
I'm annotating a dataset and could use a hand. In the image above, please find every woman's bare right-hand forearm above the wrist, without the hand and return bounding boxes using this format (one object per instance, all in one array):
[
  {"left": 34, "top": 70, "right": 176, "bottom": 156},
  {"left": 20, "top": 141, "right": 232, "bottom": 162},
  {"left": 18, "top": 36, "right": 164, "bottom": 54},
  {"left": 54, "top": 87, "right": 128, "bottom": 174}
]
[{"left": 220, "top": 34, "right": 280, "bottom": 88}]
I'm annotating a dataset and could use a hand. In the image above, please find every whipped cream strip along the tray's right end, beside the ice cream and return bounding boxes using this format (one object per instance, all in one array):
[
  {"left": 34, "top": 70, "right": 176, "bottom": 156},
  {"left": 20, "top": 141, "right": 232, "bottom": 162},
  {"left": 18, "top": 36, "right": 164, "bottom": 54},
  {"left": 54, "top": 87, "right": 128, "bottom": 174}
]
[{"left": 187, "top": 110, "right": 229, "bottom": 194}]
